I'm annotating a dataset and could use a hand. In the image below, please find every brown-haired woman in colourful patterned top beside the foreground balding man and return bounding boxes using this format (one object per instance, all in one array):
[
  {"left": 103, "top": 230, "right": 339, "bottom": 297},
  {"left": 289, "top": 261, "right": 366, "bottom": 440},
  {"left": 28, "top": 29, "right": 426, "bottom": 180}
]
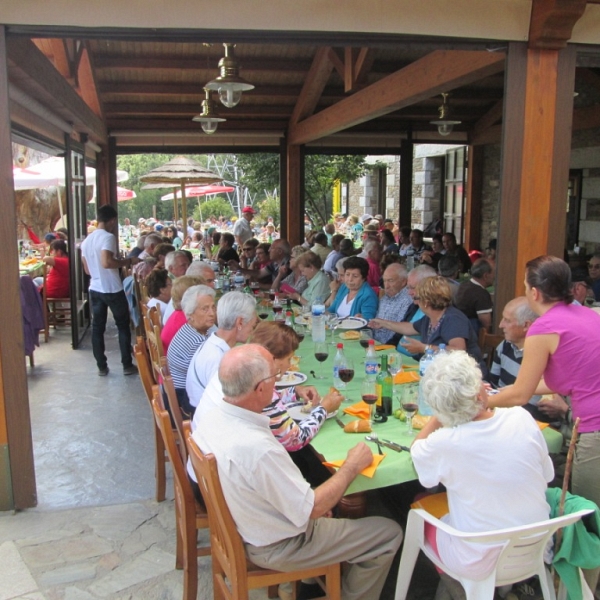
[{"left": 192, "top": 321, "right": 343, "bottom": 486}]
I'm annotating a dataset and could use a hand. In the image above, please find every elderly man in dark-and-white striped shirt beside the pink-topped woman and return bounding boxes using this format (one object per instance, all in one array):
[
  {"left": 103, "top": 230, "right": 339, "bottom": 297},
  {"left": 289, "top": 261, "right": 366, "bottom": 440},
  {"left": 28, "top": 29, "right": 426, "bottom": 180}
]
[{"left": 489, "top": 296, "right": 552, "bottom": 422}]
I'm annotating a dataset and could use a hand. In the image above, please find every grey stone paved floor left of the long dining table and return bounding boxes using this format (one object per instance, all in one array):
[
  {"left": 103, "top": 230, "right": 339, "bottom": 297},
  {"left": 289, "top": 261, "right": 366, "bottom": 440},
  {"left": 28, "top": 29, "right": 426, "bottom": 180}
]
[{"left": 0, "top": 325, "right": 437, "bottom": 600}]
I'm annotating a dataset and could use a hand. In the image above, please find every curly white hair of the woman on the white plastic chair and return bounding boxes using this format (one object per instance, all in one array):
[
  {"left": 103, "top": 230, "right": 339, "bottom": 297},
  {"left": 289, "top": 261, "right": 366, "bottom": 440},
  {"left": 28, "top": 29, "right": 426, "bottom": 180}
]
[{"left": 422, "top": 350, "right": 482, "bottom": 427}]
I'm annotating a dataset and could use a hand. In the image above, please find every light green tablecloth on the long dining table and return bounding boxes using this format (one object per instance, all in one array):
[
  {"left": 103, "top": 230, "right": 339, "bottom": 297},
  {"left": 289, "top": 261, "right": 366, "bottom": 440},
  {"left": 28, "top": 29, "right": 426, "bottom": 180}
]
[{"left": 297, "top": 332, "right": 563, "bottom": 494}]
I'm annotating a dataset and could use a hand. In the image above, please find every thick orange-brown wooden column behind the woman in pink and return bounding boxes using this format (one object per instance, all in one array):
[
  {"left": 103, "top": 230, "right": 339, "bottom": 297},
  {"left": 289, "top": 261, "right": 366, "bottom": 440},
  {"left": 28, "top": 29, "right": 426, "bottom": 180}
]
[{"left": 495, "top": 43, "right": 575, "bottom": 321}]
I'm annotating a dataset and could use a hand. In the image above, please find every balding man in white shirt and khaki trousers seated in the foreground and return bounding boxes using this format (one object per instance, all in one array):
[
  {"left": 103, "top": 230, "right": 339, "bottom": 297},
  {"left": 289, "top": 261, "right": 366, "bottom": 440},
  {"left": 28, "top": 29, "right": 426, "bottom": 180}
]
[{"left": 193, "top": 344, "right": 402, "bottom": 600}]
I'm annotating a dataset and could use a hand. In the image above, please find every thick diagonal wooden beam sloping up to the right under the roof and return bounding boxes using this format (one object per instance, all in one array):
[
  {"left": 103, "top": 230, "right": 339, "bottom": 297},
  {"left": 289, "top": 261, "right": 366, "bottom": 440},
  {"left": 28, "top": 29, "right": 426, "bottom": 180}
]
[{"left": 289, "top": 50, "right": 505, "bottom": 144}]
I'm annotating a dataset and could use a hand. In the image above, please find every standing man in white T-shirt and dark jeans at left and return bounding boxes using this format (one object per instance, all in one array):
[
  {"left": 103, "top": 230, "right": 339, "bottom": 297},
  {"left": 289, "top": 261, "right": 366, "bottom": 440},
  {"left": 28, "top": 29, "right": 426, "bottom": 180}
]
[{"left": 81, "top": 205, "right": 139, "bottom": 377}]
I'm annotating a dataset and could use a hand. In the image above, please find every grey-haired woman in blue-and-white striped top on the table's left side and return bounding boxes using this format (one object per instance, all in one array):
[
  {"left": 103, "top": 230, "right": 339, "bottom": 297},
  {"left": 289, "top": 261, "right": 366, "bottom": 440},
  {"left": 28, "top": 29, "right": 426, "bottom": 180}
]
[{"left": 167, "top": 285, "right": 217, "bottom": 417}]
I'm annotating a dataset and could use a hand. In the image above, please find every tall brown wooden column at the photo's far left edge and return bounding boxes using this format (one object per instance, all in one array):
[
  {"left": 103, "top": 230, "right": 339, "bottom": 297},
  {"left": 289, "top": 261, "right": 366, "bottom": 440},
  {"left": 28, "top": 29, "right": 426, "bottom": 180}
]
[{"left": 0, "top": 26, "right": 37, "bottom": 511}]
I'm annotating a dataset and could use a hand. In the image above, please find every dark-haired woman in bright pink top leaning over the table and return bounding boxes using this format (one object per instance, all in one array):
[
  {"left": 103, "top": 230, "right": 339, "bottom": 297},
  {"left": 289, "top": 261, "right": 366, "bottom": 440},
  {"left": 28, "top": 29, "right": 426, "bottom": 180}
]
[{"left": 490, "top": 256, "right": 600, "bottom": 512}]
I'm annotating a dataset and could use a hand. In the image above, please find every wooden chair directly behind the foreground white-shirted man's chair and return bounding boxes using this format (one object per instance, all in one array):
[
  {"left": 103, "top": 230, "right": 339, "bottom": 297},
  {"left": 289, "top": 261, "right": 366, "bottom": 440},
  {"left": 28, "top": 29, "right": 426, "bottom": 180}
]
[{"left": 152, "top": 385, "right": 211, "bottom": 600}]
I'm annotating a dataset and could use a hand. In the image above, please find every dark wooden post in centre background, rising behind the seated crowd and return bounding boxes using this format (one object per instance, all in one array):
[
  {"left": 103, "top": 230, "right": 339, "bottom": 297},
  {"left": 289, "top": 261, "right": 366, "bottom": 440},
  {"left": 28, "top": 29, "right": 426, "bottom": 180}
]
[{"left": 280, "top": 140, "right": 305, "bottom": 246}]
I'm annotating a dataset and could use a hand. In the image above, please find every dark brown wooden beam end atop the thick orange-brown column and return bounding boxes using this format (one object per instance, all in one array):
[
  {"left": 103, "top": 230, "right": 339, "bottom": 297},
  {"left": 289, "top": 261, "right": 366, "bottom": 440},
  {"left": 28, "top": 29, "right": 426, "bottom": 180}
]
[{"left": 529, "top": 0, "right": 587, "bottom": 50}]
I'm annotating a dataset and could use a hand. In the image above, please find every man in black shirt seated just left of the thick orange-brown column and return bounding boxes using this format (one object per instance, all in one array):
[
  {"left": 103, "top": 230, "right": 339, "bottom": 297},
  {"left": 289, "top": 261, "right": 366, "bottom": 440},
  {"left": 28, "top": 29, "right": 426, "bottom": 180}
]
[{"left": 454, "top": 258, "right": 494, "bottom": 333}]
